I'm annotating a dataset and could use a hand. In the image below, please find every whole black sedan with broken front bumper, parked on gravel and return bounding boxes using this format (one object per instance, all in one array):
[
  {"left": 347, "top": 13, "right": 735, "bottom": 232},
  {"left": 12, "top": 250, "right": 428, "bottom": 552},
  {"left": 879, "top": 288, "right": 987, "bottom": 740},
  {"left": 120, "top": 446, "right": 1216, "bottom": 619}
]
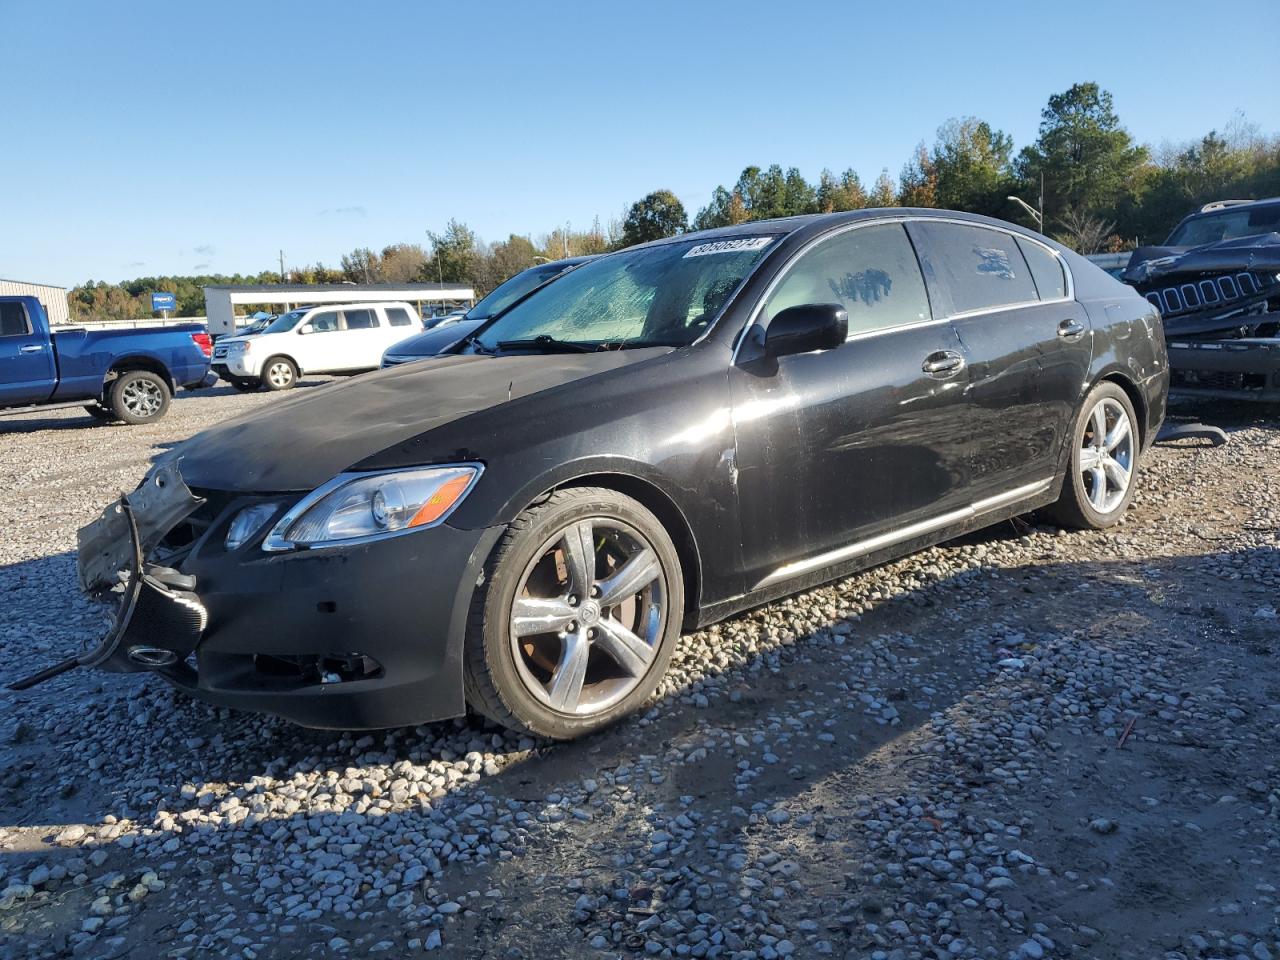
[{"left": 29, "top": 210, "right": 1169, "bottom": 739}]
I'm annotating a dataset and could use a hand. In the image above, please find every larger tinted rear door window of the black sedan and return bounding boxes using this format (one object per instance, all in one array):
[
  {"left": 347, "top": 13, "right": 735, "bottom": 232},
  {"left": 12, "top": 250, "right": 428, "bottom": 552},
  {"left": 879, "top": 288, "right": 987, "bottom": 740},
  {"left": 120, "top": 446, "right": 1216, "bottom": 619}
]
[{"left": 910, "top": 220, "right": 1039, "bottom": 314}]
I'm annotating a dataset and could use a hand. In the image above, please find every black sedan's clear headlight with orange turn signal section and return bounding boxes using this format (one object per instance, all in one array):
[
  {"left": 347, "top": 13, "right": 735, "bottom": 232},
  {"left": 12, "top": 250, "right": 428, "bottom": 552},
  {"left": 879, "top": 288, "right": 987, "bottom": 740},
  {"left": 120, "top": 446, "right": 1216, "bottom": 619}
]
[{"left": 262, "top": 463, "right": 483, "bottom": 552}]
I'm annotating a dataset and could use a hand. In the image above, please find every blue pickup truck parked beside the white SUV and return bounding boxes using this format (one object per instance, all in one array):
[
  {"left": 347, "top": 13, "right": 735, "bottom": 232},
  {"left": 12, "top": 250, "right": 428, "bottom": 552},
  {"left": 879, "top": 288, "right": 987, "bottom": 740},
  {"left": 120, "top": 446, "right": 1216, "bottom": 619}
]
[{"left": 0, "top": 297, "right": 212, "bottom": 424}]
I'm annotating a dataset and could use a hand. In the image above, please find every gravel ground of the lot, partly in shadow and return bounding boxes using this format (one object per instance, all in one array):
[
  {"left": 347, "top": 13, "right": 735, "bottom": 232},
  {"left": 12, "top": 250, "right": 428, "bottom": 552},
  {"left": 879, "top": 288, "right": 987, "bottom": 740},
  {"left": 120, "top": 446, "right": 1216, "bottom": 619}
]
[{"left": 0, "top": 388, "right": 1280, "bottom": 960}]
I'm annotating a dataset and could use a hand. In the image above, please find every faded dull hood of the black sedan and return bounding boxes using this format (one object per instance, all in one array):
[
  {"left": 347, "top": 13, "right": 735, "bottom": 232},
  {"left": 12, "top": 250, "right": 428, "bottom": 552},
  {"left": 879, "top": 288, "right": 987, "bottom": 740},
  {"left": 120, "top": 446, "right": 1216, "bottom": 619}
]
[{"left": 170, "top": 347, "right": 672, "bottom": 493}]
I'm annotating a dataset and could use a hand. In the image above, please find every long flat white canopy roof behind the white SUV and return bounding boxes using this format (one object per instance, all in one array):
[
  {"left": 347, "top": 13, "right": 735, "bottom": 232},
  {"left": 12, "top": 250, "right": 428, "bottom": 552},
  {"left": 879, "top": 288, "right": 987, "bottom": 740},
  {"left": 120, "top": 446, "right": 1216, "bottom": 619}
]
[{"left": 205, "top": 283, "right": 476, "bottom": 335}]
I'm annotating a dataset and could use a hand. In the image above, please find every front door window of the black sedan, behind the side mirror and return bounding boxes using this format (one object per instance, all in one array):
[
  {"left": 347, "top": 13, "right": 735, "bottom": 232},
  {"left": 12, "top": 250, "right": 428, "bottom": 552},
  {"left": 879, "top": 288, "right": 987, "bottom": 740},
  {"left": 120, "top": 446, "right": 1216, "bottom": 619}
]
[{"left": 764, "top": 223, "right": 933, "bottom": 337}]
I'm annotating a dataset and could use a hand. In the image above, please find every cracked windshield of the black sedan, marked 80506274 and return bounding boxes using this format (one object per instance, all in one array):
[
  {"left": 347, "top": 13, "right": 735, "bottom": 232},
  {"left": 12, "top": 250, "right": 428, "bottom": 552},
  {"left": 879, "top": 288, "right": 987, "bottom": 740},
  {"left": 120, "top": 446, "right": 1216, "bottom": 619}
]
[{"left": 475, "top": 236, "right": 776, "bottom": 351}]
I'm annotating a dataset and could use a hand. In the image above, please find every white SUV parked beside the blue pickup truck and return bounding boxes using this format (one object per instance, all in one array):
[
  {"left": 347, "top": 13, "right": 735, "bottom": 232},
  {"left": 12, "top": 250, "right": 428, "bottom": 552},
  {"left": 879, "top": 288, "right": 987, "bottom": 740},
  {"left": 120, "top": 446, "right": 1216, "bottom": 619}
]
[{"left": 212, "top": 303, "right": 422, "bottom": 390}]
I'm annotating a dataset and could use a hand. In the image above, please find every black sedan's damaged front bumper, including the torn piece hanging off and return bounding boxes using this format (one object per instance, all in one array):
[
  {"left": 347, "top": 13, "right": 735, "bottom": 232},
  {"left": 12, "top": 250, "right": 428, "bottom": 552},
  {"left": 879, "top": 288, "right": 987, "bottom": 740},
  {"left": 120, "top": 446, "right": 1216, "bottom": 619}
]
[{"left": 15, "top": 463, "right": 499, "bottom": 730}]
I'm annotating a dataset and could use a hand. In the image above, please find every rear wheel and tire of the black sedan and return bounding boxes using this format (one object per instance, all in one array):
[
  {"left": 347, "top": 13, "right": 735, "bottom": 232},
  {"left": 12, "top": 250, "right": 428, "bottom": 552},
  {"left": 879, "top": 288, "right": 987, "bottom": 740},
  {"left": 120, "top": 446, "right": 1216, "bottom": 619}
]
[{"left": 1050, "top": 381, "right": 1140, "bottom": 530}]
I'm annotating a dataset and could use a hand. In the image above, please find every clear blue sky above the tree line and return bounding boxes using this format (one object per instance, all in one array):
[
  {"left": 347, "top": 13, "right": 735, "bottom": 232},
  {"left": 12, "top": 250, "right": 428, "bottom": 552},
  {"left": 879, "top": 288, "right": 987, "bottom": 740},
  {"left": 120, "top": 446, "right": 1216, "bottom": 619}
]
[{"left": 0, "top": 0, "right": 1280, "bottom": 285}]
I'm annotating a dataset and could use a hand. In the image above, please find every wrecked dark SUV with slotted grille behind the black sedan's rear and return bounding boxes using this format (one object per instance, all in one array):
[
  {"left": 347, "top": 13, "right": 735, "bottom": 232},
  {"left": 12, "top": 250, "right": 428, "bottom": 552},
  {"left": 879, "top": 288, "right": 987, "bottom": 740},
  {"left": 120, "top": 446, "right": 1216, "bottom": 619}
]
[{"left": 1123, "top": 197, "right": 1280, "bottom": 402}]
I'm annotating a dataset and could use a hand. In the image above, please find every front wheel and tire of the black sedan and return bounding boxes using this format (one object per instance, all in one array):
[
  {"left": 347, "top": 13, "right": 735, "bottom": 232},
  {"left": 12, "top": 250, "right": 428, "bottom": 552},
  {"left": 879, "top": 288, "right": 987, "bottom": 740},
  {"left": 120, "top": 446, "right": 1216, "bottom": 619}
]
[{"left": 465, "top": 488, "right": 685, "bottom": 740}]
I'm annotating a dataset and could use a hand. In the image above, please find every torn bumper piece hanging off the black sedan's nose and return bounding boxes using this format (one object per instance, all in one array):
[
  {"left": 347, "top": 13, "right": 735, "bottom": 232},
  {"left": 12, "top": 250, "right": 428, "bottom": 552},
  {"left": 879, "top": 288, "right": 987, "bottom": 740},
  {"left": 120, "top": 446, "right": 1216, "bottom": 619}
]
[{"left": 10, "top": 463, "right": 209, "bottom": 690}]
